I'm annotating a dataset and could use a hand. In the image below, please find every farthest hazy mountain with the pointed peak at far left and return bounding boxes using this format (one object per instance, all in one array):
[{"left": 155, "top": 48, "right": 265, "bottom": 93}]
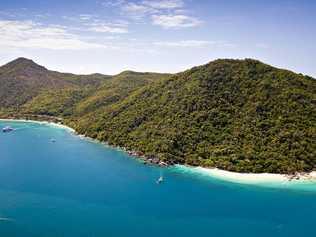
[{"left": 0, "top": 58, "right": 108, "bottom": 108}]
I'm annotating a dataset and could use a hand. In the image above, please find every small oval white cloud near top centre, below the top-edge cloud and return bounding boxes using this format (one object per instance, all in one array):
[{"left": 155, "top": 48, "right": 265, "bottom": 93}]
[{"left": 152, "top": 15, "right": 202, "bottom": 29}]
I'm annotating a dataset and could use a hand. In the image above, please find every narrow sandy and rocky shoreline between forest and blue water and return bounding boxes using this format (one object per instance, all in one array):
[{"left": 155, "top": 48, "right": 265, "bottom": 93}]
[{"left": 0, "top": 119, "right": 316, "bottom": 185}]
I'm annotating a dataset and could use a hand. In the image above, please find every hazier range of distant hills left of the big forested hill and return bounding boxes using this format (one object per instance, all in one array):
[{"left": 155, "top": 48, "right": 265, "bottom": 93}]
[{"left": 0, "top": 58, "right": 168, "bottom": 116}]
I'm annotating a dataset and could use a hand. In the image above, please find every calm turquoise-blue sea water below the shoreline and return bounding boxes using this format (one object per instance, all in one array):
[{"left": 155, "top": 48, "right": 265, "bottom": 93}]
[{"left": 0, "top": 121, "right": 316, "bottom": 237}]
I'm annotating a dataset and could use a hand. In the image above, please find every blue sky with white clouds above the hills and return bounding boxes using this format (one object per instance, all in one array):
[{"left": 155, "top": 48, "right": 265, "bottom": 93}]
[{"left": 0, "top": 0, "right": 316, "bottom": 78}]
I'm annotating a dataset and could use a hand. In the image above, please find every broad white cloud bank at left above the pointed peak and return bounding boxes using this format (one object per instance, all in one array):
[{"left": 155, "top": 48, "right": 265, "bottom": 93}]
[{"left": 0, "top": 20, "right": 110, "bottom": 50}]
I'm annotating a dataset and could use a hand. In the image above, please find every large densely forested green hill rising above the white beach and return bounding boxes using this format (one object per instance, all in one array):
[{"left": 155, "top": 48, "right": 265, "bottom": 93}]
[{"left": 0, "top": 59, "right": 316, "bottom": 173}]
